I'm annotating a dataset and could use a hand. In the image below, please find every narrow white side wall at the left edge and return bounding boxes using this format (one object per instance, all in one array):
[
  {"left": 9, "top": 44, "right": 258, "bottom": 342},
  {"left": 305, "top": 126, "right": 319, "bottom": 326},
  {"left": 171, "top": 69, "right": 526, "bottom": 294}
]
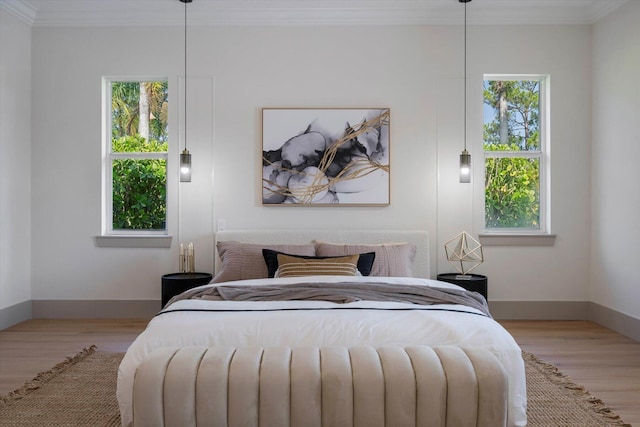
[{"left": 0, "top": 8, "right": 31, "bottom": 318}]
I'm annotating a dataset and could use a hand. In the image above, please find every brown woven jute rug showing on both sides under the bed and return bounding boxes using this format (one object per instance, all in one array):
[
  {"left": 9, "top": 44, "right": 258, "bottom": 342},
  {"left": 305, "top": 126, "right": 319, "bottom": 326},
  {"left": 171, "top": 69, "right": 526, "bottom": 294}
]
[{"left": 0, "top": 346, "right": 630, "bottom": 427}]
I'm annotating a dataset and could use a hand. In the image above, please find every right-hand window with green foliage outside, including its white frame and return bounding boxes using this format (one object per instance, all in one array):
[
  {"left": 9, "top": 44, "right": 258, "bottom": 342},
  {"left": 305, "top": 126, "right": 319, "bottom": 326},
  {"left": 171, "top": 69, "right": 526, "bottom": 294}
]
[{"left": 483, "top": 76, "right": 549, "bottom": 234}]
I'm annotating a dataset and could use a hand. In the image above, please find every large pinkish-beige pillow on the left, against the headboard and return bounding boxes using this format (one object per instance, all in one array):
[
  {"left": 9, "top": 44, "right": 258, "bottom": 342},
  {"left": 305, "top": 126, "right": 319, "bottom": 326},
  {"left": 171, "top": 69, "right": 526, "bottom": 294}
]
[{"left": 211, "top": 240, "right": 316, "bottom": 283}]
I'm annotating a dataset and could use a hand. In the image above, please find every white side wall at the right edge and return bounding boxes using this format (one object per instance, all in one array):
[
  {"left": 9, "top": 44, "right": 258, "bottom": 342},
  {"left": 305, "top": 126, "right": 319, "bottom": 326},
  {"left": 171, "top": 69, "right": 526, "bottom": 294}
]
[{"left": 590, "top": 2, "right": 640, "bottom": 319}]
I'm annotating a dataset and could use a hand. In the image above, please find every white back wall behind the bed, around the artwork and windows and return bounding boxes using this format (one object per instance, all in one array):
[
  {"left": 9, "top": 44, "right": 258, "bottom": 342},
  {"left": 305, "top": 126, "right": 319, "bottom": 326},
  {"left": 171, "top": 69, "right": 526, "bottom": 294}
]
[{"left": 25, "top": 26, "right": 591, "bottom": 308}]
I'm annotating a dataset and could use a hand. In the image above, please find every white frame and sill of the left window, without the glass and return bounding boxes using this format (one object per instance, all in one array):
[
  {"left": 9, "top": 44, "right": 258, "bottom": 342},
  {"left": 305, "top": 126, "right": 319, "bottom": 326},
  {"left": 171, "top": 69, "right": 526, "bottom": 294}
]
[{"left": 95, "top": 76, "right": 171, "bottom": 244}]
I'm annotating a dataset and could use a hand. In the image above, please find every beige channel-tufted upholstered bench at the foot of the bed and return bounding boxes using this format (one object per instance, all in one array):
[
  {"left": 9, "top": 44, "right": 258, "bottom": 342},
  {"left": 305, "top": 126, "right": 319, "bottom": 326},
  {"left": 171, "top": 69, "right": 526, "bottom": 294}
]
[{"left": 133, "top": 346, "right": 508, "bottom": 427}]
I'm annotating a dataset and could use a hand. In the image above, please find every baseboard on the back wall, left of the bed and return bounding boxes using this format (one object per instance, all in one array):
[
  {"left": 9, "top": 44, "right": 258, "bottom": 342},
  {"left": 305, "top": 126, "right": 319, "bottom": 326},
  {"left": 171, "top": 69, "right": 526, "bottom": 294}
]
[{"left": 32, "top": 300, "right": 160, "bottom": 319}]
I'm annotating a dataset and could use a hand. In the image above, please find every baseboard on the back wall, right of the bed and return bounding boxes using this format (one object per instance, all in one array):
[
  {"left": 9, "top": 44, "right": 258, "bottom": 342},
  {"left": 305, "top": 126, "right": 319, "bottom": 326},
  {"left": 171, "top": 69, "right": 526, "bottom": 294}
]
[{"left": 489, "top": 301, "right": 590, "bottom": 320}]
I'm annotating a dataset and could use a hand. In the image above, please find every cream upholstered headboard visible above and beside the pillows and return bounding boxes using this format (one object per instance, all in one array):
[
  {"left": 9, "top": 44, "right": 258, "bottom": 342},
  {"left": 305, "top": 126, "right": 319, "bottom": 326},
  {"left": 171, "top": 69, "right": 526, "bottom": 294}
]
[{"left": 214, "top": 229, "right": 430, "bottom": 279}]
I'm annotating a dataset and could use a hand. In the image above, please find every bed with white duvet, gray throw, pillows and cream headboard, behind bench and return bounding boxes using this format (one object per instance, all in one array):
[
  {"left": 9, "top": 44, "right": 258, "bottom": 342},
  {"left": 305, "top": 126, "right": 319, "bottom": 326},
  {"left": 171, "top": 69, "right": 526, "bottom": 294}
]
[{"left": 117, "top": 230, "right": 526, "bottom": 426}]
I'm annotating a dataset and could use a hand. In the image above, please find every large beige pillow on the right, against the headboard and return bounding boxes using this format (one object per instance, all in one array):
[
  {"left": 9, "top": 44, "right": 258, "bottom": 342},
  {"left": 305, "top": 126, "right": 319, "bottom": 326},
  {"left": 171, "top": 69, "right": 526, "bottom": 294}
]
[{"left": 316, "top": 242, "right": 416, "bottom": 277}]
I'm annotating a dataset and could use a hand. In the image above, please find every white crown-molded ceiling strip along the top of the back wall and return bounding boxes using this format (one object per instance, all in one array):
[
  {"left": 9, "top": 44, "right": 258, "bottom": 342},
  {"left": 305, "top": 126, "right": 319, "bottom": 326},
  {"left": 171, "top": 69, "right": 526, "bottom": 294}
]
[{"left": 0, "top": 0, "right": 640, "bottom": 26}]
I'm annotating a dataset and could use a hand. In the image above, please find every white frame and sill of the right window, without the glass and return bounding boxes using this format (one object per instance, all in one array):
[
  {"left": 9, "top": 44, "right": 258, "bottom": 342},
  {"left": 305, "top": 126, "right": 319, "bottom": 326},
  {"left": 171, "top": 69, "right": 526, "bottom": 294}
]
[{"left": 474, "top": 74, "right": 556, "bottom": 246}]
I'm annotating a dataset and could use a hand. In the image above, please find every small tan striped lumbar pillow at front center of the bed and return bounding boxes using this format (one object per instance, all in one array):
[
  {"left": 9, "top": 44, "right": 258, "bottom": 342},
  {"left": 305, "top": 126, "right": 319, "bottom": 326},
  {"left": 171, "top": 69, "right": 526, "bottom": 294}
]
[{"left": 275, "top": 254, "right": 359, "bottom": 277}]
